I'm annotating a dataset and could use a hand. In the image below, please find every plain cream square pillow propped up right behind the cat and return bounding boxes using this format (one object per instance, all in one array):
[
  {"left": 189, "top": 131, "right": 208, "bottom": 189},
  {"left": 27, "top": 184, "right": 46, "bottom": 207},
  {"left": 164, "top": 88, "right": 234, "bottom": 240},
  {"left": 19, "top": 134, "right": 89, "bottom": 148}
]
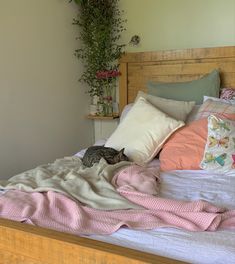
[{"left": 105, "top": 97, "right": 184, "bottom": 165}]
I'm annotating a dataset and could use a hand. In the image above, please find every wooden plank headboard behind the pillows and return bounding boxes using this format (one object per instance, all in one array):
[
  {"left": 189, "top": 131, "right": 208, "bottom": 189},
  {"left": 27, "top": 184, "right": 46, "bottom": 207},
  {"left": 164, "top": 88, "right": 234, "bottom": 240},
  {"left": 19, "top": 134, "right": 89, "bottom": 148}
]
[{"left": 119, "top": 46, "right": 235, "bottom": 111}]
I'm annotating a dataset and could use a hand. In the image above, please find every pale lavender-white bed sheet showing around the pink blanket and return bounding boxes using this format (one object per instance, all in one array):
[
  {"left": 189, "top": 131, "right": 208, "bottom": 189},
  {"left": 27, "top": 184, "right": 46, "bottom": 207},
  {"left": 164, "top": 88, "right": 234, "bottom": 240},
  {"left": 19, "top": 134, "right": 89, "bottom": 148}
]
[{"left": 76, "top": 145, "right": 235, "bottom": 264}]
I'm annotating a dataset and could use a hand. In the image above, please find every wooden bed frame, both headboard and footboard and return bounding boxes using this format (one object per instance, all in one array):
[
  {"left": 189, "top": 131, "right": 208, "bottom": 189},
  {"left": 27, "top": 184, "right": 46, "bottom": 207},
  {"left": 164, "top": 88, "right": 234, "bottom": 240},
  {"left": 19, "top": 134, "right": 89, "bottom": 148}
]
[{"left": 0, "top": 46, "right": 235, "bottom": 264}]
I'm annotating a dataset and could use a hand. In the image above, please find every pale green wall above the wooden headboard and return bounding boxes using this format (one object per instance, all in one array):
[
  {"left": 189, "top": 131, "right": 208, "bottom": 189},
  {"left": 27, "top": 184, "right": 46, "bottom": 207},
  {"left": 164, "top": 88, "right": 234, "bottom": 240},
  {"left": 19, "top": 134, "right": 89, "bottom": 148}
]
[{"left": 120, "top": 0, "right": 235, "bottom": 52}]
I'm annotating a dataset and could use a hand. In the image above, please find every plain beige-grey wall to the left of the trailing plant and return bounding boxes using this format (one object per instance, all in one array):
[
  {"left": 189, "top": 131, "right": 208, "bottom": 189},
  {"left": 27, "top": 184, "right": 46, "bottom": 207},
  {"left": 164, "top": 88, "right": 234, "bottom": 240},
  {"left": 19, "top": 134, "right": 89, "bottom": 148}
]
[{"left": 0, "top": 0, "right": 93, "bottom": 178}]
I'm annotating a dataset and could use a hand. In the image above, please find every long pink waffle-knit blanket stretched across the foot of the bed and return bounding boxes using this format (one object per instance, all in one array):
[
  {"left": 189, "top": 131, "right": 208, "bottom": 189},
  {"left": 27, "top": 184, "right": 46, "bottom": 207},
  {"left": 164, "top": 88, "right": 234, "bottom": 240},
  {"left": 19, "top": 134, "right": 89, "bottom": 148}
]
[{"left": 0, "top": 188, "right": 235, "bottom": 235}]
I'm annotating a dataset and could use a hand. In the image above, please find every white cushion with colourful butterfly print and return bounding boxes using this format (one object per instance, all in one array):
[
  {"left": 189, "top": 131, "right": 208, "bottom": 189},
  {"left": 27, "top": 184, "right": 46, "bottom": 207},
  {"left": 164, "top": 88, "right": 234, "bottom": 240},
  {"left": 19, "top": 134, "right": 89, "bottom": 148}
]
[{"left": 200, "top": 115, "right": 235, "bottom": 173}]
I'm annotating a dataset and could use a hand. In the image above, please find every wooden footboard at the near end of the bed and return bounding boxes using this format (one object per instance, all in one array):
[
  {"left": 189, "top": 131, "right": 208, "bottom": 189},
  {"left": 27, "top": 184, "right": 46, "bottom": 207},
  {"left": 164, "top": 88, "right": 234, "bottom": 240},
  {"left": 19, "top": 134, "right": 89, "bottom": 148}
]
[{"left": 0, "top": 219, "right": 183, "bottom": 264}]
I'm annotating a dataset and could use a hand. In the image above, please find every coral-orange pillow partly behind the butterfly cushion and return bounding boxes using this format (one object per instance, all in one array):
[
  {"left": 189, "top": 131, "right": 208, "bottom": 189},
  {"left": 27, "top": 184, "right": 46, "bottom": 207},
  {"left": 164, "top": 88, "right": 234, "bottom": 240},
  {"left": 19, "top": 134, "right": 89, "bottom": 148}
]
[{"left": 159, "top": 114, "right": 235, "bottom": 171}]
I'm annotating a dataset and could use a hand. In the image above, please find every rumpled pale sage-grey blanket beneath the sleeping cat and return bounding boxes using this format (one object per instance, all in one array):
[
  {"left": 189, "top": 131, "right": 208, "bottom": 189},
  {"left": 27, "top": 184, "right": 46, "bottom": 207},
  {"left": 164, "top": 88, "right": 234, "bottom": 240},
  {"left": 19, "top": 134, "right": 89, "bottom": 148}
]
[{"left": 0, "top": 156, "right": 140, "bottom": 210}]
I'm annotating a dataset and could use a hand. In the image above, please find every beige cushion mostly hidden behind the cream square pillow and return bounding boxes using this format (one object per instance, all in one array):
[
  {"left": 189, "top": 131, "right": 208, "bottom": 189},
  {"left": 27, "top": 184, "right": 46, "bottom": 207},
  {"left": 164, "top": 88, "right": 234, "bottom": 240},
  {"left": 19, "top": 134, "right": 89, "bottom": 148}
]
[{"left": 136, "top": 91, "right": 195, "bottom": 121}]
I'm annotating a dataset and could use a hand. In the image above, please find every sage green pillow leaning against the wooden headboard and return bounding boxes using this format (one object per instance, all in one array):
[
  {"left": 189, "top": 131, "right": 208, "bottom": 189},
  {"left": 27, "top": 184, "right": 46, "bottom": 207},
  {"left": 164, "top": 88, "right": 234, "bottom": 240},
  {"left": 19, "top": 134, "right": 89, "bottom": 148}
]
[{"left": 147, "top": 70, "right": 220, "bottom": 104}]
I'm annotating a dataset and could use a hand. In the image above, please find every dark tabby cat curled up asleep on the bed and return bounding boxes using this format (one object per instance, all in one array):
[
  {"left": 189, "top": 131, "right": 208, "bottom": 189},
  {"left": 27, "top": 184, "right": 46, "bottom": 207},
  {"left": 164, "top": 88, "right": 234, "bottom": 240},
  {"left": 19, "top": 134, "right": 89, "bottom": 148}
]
[{"left": 82, "top": 146, "right": 128, "bottom": 167}]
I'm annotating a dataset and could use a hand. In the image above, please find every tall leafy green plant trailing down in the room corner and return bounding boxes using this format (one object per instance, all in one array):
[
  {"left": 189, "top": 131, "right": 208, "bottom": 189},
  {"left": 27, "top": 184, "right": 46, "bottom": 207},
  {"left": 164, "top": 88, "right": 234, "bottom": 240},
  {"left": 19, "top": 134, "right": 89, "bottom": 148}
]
[{"left": 73, "top": 0, "right": 126, "bottom": 96}]
